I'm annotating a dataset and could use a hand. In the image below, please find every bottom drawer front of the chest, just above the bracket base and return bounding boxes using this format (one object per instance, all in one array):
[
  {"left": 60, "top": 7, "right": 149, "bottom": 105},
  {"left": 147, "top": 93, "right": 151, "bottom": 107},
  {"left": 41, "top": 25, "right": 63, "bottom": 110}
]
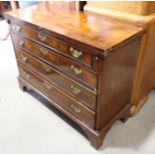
[{"left": 19, "top": 65, "right": 95, "bottom": 128}]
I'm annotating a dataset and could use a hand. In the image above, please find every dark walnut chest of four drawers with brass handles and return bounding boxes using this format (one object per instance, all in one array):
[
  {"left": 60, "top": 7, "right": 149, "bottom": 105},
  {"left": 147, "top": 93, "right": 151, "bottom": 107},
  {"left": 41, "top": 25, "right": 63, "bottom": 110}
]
[{"left": 5, "top": 3, "right": 144, "bottom": 148}]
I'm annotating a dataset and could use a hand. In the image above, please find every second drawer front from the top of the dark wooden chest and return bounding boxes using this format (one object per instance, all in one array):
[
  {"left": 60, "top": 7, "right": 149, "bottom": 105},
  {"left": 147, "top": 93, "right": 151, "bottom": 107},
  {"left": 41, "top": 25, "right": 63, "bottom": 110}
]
[{"left": 12, "top": 34, "right": 97, "bottom": 90}]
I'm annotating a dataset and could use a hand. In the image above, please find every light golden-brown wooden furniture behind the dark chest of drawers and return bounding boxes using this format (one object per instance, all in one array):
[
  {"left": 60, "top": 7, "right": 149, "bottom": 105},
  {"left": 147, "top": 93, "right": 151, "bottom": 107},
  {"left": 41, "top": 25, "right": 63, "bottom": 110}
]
[{"left": 85, "top": 1, "right": 155, "bottom": 116}]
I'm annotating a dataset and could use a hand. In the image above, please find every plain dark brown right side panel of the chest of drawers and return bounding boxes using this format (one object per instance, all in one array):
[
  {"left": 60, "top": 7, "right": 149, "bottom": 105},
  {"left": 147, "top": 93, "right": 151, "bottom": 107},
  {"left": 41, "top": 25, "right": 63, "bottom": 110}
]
[{"left": 96, "top": 38, "right": 141, "bottom": 129}]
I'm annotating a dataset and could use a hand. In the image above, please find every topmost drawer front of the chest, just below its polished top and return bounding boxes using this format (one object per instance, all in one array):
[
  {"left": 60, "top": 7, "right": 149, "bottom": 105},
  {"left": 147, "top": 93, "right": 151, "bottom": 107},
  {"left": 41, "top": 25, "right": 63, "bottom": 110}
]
[{"left": 11, "top": 24, "right": 92, "bottom": 66}]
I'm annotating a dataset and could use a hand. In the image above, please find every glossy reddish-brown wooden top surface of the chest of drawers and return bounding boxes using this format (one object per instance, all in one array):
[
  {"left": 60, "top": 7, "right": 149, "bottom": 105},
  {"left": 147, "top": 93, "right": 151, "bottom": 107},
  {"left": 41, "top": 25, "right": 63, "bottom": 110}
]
[{"left": 5, "top": 2, "right": 142, "bottom": 50}]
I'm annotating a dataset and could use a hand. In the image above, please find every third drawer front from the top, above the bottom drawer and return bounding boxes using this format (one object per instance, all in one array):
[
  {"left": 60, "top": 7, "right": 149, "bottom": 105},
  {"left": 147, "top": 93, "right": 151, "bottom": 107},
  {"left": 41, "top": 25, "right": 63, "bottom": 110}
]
[{"left": 16, "top": 49, "right": 97, "bottom": 110}]
